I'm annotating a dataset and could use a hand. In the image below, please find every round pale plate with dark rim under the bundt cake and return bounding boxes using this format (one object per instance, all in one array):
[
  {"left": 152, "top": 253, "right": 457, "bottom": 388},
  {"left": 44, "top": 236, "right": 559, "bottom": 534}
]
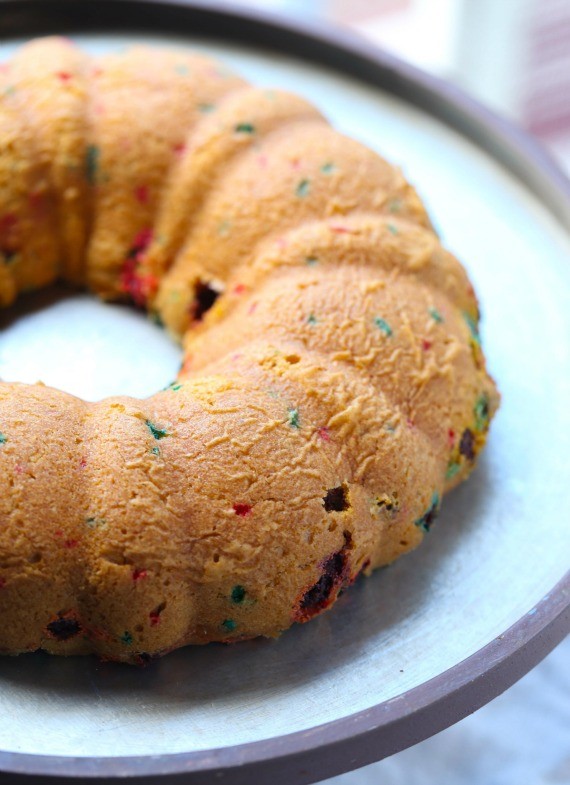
[{"left": 0, "top": 0, "right": 570, "bottom": 785}]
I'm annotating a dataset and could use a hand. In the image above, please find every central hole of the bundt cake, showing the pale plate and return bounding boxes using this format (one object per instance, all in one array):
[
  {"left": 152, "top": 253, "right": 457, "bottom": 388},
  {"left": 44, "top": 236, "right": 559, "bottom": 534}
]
[{"left": 0, "top": 286, "right": 182, "bottom": 401}]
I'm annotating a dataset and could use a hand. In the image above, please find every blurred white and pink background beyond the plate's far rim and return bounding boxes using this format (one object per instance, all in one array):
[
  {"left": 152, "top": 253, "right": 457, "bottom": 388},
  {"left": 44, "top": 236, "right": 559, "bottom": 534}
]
[{"left": 241, "top": 0, "right": 570, "bottom": 171}]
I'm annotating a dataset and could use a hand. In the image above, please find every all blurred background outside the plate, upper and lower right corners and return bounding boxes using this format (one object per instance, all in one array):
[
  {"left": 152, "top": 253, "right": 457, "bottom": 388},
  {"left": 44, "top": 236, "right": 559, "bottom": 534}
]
[{"left": 236, "top": 0, "right": 570, "bottom": 785}]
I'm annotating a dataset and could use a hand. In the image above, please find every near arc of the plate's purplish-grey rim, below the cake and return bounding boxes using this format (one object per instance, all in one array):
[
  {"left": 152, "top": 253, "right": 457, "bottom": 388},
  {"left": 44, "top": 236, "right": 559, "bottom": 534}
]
[{"left": 0, "top": 574, "right": 570, "bottom": 785}]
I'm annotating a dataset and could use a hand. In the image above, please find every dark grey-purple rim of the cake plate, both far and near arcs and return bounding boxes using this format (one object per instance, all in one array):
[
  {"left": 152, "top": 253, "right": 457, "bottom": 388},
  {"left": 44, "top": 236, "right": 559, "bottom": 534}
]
[{"left": 0, "top": 0, "right": 570, "bottom": 785}]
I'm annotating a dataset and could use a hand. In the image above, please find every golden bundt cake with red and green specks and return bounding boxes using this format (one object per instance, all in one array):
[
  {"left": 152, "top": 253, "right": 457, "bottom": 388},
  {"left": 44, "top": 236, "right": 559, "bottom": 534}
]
[{"left": 0, "top": 38, "right": 498, "bottom": 662}]
